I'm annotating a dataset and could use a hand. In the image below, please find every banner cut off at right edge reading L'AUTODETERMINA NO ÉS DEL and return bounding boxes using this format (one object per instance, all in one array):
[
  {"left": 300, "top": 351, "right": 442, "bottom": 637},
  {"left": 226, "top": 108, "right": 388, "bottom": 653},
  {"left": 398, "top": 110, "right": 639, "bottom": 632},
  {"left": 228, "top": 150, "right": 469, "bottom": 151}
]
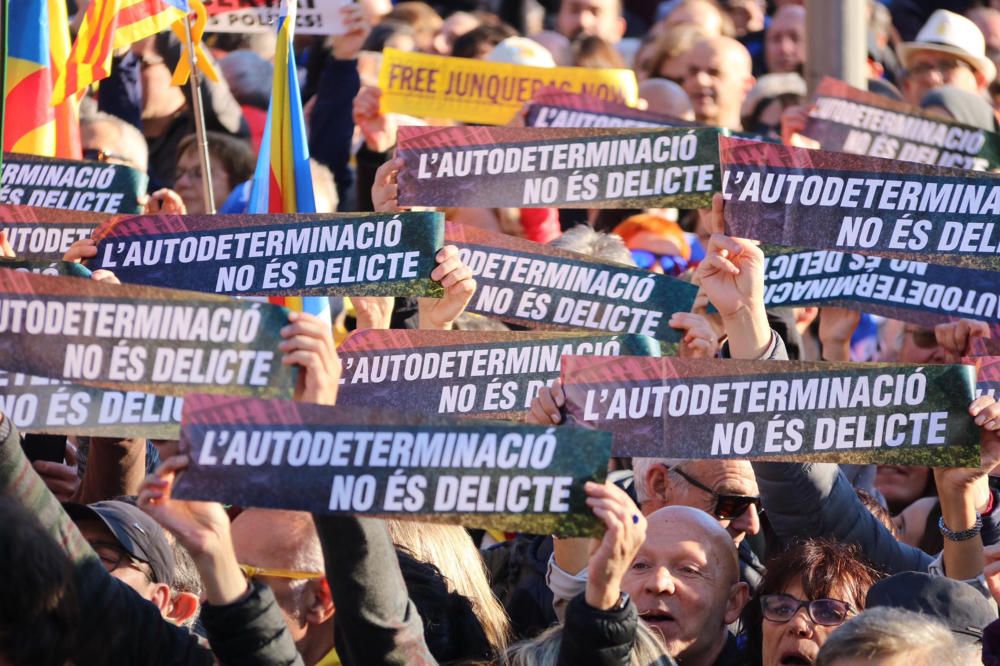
[{"left": 719, "top": 137, "right": 1000, "bottom": 270}]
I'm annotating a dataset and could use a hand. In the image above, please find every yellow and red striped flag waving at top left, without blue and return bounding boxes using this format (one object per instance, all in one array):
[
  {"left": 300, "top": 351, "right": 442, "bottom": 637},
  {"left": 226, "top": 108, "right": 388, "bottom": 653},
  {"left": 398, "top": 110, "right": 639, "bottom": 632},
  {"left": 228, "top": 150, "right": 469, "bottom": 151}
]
[{"left": 53, "top": 0, "right": 190, "bottom": 103}]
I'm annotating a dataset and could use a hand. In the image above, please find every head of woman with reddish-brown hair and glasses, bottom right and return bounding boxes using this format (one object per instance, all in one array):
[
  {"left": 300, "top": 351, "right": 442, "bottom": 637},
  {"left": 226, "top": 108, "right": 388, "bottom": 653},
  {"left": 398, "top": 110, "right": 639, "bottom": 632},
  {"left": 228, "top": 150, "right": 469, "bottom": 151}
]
[{"left": 743, "top": 539, "right": 878, "bottom": 666}]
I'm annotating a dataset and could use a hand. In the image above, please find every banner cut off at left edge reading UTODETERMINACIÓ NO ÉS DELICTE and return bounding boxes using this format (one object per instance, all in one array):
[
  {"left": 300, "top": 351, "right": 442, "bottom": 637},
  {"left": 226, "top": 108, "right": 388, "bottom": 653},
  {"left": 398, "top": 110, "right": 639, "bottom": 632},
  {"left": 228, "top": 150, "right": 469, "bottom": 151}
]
[{"left": 0, "top": 268, "right": 296, "bottom": 397}]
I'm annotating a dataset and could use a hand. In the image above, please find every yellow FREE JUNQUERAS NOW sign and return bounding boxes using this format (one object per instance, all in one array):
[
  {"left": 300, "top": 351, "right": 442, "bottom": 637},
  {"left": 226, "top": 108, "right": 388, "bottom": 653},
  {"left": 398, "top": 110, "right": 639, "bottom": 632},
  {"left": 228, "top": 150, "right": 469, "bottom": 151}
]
[{"left": 378, "top": 48, "right": 639, "bottom": 125}]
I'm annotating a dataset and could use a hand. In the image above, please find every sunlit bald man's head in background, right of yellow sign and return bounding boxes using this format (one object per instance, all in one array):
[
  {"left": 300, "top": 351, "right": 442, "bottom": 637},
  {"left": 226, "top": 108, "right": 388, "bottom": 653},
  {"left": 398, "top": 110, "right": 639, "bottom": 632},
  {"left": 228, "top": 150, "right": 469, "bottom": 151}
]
[{"left": 681, "top": 37, "right": 755, "bottom": 130}]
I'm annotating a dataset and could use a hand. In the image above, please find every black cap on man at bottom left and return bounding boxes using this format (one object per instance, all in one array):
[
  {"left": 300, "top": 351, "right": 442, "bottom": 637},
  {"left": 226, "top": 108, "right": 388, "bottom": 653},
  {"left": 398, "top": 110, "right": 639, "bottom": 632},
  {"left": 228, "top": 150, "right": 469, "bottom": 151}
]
[{"left": 63, "top": 500, "right": 174, "bottom": 586}]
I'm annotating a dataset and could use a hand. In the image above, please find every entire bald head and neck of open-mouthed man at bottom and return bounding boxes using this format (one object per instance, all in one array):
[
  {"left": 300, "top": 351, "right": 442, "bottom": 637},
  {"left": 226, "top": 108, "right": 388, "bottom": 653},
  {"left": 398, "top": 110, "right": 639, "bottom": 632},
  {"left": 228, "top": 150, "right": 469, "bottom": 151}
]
[{"left": 622, "top": 506, "right": 750, "bottom": 666}]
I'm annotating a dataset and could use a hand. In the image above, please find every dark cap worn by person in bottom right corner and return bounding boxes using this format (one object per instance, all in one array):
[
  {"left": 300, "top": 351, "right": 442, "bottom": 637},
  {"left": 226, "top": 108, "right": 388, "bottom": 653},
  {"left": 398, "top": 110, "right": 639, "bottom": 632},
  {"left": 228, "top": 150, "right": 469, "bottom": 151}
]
[{"left": 866, "top": 571, "right": 997, "bottom": 644}]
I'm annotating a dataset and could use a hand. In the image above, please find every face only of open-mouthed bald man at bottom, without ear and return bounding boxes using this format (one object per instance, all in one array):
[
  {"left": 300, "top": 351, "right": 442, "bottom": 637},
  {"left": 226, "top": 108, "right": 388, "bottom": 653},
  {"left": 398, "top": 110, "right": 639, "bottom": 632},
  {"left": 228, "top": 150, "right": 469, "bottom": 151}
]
[{"left": 622, "top": 514, "right": 738, "bottom": 657}]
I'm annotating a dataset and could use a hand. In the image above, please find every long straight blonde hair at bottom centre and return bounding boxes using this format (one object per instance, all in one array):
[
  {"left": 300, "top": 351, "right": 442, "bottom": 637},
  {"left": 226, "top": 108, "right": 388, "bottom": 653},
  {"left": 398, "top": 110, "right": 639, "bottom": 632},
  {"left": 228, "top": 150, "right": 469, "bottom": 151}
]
[{"left": 386, "top": 520, "right": 510, "bottom": 654}]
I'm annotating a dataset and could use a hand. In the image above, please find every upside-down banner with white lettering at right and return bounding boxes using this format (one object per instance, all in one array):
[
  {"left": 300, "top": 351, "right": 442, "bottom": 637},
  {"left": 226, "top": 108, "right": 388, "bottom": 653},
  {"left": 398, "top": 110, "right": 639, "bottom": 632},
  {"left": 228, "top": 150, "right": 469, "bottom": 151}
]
[{"left": 761, "top": 246, "right": 1000, "bottom": 326}]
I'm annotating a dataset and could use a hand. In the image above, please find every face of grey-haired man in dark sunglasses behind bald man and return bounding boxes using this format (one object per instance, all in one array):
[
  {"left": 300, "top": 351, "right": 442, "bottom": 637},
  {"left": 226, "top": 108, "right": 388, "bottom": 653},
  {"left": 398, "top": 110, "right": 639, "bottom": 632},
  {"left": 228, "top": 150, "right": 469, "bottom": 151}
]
[{"left": 671, "top": 460, "right": 760, "bottom": 545}]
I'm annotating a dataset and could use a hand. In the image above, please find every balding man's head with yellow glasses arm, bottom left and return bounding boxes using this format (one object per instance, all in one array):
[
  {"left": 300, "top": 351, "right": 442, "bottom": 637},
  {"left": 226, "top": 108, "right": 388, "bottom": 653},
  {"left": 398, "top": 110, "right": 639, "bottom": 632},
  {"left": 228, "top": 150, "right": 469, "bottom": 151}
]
[{"left": 232, "top": 509, "right": 339, "bottom": 666}]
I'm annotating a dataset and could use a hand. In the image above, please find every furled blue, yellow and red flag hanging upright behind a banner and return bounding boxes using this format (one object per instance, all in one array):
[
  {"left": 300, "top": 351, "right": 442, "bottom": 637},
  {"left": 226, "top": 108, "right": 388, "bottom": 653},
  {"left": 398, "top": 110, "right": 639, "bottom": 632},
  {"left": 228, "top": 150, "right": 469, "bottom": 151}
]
[{"left": 249, "top": 1, "right": 330, "bottom": 321}]
